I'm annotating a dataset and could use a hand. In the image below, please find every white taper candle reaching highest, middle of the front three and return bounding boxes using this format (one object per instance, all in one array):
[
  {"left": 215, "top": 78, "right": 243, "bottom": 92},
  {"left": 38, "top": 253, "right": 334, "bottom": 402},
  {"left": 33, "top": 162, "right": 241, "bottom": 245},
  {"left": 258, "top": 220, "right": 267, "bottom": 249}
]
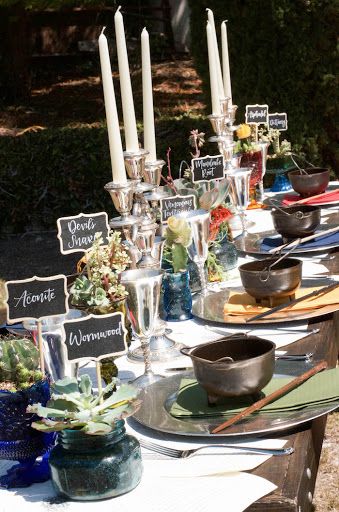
[{"left": 114, "top": 7, "right": 139, "bottom": 151}]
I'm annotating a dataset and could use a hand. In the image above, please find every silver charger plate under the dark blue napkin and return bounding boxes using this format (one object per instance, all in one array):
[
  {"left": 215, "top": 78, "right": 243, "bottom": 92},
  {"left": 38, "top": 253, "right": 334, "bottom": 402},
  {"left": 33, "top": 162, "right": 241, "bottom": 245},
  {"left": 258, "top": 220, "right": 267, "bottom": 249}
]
[{"left": 234, "top": 224, "right": 339, "bottom": 257}]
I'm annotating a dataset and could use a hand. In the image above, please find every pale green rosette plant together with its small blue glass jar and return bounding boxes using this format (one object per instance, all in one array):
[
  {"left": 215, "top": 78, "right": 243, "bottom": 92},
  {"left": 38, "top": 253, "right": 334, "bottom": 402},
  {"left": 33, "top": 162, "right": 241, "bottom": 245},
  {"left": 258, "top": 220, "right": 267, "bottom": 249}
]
[{"left": 163, "top": 216, "right": 192, "bottom": 321}]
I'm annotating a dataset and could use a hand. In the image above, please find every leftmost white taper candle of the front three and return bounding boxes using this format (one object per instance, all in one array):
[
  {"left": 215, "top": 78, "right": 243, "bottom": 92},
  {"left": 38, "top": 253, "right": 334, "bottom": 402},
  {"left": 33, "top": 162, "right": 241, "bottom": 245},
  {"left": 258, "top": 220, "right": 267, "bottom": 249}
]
[{"left": 98, "top": 29, "right": 127, "bottom": 184}]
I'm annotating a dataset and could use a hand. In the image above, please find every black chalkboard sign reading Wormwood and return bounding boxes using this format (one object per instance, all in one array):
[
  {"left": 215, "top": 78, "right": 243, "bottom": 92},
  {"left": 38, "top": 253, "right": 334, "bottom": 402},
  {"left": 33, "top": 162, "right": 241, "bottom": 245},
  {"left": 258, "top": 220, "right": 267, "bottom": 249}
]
[{"left": 62, "top": 313, "right": 127, "bottom": 361}]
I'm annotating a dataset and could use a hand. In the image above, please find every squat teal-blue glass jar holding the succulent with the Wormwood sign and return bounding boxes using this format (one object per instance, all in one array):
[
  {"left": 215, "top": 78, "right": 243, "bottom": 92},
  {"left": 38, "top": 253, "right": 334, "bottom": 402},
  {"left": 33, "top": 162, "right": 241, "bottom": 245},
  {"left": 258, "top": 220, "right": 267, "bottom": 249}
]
[{"left": 49, "top": 420, "right": 142, "bottom": 501}]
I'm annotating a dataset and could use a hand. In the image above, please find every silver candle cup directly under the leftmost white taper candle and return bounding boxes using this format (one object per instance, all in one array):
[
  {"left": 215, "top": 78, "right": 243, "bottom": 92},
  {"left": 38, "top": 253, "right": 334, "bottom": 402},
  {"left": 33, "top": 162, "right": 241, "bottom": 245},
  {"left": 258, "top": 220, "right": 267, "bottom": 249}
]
[{"left": 104, "top": 180, "right": 140, "bottom": 229}]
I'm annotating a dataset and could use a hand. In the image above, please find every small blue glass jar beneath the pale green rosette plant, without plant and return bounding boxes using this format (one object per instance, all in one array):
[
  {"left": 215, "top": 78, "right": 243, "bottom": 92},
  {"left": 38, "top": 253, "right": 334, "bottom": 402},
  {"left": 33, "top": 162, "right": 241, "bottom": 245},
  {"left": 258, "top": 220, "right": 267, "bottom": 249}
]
[{"left": 162, "top": 270, "right": 192, "bottom": 322}]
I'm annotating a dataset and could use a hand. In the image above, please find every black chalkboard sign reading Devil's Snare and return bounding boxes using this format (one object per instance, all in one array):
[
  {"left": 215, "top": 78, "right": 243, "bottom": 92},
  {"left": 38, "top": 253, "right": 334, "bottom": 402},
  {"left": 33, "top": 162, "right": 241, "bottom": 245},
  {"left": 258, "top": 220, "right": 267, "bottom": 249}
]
[{"left": 57, "top": 212, "right": 109, "bottom": 254}]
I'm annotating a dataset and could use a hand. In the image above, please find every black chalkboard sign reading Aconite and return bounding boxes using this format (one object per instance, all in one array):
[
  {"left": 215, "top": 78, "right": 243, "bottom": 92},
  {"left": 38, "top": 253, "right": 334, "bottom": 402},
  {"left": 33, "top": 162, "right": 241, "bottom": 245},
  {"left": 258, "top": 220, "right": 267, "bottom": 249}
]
[{"left": 6, "top": 275, "right": 68, "bottom": 323}]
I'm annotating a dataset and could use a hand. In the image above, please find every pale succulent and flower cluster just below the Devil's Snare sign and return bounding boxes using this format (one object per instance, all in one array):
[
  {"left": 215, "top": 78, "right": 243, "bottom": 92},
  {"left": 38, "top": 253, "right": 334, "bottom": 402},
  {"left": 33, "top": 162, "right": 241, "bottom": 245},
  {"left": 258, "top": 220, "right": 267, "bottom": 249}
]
[{"left": 70, "top": 231, "right": 130, "bottom": 312}]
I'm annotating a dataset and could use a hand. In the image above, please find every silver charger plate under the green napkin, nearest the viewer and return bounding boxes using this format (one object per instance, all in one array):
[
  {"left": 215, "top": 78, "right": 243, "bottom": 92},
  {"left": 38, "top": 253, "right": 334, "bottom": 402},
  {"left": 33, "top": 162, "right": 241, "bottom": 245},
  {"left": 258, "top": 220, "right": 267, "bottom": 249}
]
[{"left": 133, "top": 371, "right": 339, "bottom": 437}]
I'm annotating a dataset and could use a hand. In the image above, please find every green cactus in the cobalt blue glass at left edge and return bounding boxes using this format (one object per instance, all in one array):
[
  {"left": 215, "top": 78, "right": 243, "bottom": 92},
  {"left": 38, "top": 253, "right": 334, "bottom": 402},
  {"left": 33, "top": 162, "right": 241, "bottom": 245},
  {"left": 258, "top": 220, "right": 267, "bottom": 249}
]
[{"left": 0, "top": 336, "right": 43, "bottom": 391}]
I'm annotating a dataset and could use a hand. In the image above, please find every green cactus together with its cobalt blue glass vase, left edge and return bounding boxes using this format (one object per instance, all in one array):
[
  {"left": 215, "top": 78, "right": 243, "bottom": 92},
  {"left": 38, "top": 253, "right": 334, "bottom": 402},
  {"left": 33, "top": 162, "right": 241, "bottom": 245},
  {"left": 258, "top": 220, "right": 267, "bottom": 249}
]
[{"left": 0, "top": 335, "right": 55, "bottom": 488}]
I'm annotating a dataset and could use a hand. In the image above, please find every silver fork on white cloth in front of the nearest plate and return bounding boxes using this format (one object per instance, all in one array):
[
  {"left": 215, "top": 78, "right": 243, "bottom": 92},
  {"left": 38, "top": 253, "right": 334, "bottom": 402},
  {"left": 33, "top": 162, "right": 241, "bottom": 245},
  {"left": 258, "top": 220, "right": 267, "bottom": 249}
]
[{"left": 139, "top": 439, "right": 294, "bottom": 459}]
